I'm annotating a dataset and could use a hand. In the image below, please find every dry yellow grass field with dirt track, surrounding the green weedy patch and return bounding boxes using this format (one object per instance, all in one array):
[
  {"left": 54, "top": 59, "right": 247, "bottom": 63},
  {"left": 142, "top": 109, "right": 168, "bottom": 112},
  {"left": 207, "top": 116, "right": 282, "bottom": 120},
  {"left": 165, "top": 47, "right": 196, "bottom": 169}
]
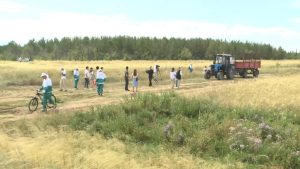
[{"left": 0, "top": 60, "right": 300, "bottom": 168}]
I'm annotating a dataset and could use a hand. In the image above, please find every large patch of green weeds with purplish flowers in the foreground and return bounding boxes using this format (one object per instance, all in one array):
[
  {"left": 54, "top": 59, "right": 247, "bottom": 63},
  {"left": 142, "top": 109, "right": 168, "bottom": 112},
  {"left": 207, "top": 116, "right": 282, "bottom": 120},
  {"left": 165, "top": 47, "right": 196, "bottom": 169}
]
[{"left": 5, "top": 91, "right": 300, "bottom": 168}]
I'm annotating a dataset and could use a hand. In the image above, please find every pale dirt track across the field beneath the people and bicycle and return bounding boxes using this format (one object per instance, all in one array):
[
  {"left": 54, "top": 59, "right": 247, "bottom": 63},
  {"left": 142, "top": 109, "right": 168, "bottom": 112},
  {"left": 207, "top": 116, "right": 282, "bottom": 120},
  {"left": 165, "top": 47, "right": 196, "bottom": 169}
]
[{"left": 0, "top": 75, "right": 268, "bottom": 122}]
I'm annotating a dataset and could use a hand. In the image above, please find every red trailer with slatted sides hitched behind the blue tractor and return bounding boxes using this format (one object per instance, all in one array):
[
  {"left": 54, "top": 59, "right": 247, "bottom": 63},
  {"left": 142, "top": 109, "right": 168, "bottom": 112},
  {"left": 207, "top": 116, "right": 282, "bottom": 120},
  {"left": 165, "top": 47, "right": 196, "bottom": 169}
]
[{"left": 233, "top": 54, "right": 261, "bottom": 78}]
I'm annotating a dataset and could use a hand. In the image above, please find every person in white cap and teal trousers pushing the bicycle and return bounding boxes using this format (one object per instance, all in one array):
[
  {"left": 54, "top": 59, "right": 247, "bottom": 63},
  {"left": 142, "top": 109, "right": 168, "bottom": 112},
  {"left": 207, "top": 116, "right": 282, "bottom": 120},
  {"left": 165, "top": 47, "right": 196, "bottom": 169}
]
[{"left": 39, "top": 73, "right": 55, "bottom": 111}]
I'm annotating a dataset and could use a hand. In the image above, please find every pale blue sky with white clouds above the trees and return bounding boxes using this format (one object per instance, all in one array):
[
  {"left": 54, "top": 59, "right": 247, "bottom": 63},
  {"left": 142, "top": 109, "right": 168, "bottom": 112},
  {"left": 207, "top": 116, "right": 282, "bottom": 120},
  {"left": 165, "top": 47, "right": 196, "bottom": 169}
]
[{"left": 0, "top": 0, "right": 300, "bottom": 51}]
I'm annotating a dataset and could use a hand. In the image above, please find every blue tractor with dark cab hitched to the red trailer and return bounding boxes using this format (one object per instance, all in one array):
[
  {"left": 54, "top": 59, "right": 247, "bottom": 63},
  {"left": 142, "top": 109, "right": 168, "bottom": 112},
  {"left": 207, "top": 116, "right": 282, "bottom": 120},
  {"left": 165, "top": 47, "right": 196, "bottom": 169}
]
[{"left": 204, "top": 54, "right": 235, "bottom": 80}]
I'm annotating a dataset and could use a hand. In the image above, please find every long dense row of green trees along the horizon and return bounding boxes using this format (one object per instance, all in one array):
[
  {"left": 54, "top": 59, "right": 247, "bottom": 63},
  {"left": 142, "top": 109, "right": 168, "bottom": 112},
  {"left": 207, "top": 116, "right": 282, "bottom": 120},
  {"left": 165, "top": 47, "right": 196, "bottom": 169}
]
[{"left": 0, "top": 36, "right": 297, "bottom": 61}]
